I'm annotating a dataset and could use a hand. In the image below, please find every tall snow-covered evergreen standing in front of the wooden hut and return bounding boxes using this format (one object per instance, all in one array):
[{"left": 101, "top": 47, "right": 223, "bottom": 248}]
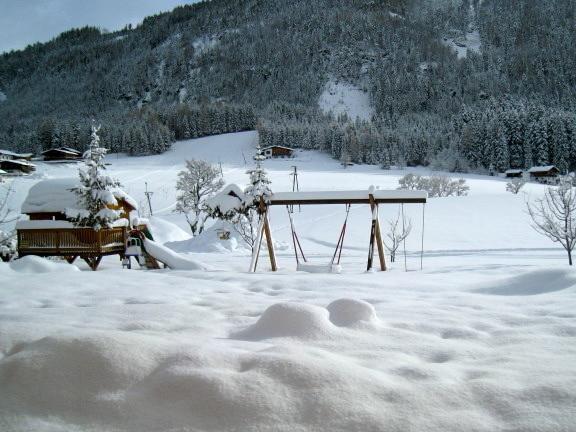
[{"left": 71, "top": 125, "right": 120, "bottom": 230}]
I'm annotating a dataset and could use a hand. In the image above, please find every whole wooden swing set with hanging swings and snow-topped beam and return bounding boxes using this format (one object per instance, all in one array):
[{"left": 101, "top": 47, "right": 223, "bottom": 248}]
[{"left": 250, "top": 187, "right": 428, "bottom": 273}]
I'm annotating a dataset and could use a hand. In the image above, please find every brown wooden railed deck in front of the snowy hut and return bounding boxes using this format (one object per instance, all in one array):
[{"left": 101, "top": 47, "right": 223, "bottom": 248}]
[{"left": 18, "top": 227, "right": 128, "bottom": 270}]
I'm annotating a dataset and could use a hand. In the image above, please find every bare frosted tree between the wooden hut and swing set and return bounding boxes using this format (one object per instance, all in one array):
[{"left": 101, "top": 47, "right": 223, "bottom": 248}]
[{"left": 176, "top": 159, "right": 224, "bottom": 236}]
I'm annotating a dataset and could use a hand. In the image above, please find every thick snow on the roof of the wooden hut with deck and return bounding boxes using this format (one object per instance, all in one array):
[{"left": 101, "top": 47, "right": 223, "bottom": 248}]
[{"left": 21, "top": 178, "right": 138, "bottom": 213}]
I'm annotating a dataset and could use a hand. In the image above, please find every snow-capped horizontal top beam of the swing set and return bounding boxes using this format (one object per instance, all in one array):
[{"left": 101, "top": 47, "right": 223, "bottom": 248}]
[{"left": 270, "top": 189, "right": 428, "bottom": 205}]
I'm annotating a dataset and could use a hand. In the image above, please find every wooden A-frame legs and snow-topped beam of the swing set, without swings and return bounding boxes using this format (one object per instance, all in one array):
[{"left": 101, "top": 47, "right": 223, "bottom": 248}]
[{"left": 249, "top": 189, "right": 427, "bottom": 273}]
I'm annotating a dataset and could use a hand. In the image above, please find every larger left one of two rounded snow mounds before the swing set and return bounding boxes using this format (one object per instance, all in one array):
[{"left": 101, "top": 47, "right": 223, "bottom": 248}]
[{"left": 232, "top": 303, "right": 334, "bottom": 340}]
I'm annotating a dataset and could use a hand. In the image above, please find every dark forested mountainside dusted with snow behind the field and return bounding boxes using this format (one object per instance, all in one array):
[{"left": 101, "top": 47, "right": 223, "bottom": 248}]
[{"left": 0, "top": 0, "right": 576, "bottom": 170}]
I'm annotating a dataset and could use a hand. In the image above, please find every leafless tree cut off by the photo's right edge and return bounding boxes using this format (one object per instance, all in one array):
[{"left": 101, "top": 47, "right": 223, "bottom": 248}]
[{"left": 526, "top": 178, "right": 576, "bottom": 265}]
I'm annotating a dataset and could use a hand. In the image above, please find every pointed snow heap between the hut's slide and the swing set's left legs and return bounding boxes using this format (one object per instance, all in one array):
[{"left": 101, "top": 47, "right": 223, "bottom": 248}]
[{"left": 166, "top": 221, "right": 249, "bottom": 253}]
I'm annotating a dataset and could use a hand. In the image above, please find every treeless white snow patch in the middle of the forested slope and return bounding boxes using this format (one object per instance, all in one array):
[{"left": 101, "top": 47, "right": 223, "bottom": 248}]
[{"left": 318, "top": 80, "right": 374, "bottom": 120}]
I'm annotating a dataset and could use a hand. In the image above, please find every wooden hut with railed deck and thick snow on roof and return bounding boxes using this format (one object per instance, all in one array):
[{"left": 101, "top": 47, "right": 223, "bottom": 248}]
[{"left": 16, "top": 178, "right": 137, "bottom": 270}]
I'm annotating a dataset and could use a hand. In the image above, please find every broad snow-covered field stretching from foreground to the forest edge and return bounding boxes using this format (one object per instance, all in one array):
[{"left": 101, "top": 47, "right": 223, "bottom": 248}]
[{"left": 0, "top": 132, "right": 576, "bottom": 432}]
